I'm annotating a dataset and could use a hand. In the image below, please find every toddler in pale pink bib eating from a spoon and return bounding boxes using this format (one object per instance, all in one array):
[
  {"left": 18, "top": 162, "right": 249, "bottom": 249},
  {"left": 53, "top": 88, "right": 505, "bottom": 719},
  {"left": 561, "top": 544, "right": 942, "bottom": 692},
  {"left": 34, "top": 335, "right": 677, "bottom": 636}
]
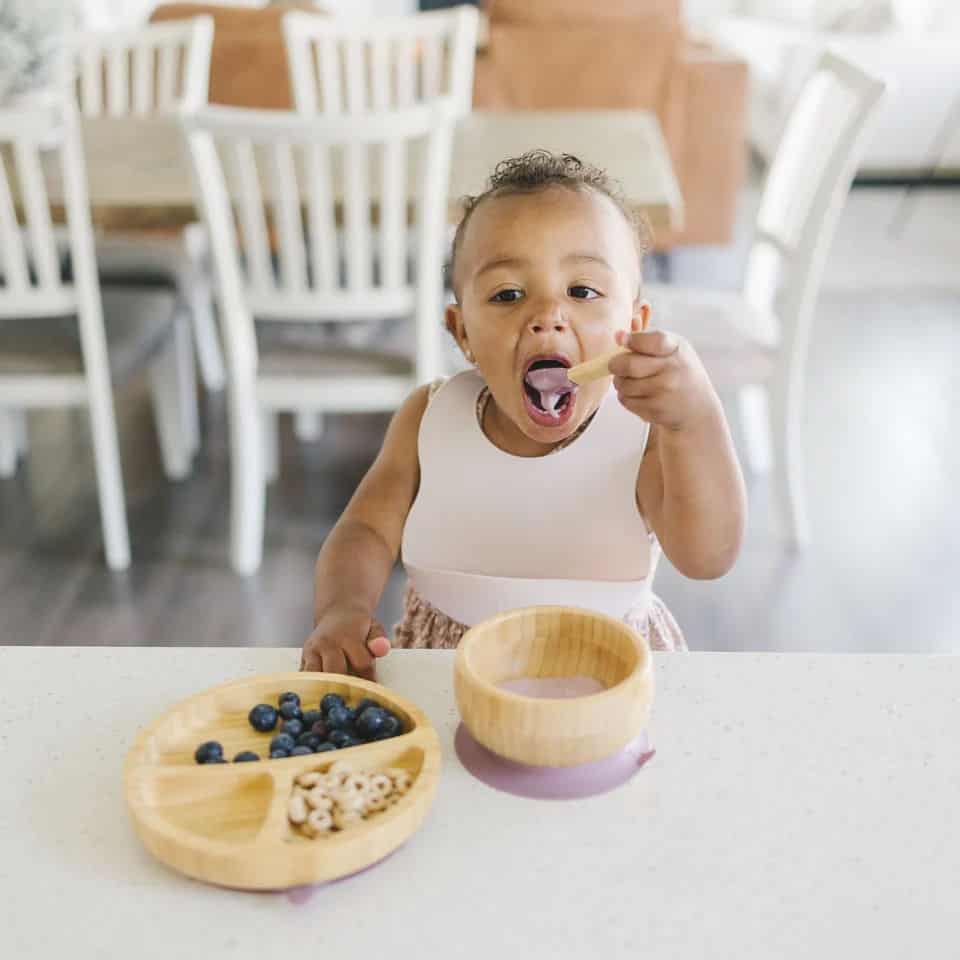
[{"left": 303, "top": 151, "right": 745, "bottom": 677}]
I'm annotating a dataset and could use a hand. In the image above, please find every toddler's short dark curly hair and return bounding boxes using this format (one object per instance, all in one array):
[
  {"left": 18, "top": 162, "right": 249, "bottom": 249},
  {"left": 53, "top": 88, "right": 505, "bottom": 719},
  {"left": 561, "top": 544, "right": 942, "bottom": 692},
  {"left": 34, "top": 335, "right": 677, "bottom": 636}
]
[{"left": 446, "top": 150, "right": 652, "bottom": 290}]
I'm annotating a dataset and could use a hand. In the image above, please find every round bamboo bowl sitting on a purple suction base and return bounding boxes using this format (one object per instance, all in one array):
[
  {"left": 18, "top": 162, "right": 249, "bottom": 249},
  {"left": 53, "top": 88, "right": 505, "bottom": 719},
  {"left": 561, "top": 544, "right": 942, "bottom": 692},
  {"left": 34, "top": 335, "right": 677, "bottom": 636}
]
[{"left": 454, "top": 607, "right": 653, "bottom": 767}]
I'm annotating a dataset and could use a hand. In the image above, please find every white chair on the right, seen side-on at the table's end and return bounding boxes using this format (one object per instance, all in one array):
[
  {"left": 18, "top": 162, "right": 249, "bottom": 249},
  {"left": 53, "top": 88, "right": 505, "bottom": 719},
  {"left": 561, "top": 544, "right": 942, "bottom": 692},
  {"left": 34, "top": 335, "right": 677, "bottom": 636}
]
[{"left": 646, "top": 53, "right": 884, "bottom": 545}]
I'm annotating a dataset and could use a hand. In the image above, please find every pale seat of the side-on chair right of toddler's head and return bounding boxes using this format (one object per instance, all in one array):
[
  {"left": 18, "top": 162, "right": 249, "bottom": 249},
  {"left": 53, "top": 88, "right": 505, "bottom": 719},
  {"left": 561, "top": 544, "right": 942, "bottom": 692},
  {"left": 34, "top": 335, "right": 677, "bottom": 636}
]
[{"left": 644, "top": 283, "right": 780, "bottom": 388}]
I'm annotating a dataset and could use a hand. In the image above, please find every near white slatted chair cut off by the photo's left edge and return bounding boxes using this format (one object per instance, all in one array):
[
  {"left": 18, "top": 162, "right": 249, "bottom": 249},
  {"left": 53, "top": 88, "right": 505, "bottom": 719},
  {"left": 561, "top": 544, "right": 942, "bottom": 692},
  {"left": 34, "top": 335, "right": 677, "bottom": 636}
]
[{"left": 0, "top": 100, "right": 196, "bottom": 570}]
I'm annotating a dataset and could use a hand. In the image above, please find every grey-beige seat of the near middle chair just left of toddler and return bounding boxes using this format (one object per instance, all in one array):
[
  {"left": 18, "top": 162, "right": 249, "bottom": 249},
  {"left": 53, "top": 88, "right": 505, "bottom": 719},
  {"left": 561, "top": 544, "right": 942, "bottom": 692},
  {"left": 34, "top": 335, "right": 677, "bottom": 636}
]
[{"left": 256, "top": 321, "right": 414, "bottom": 379}]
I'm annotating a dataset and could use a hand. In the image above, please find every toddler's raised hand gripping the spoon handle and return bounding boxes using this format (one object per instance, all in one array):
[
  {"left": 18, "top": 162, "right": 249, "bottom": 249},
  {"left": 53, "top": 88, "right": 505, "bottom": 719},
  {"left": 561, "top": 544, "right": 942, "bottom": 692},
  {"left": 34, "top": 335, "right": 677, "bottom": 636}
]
[{"left": 610, "top": 330, "right": 718, "bottom": 430}]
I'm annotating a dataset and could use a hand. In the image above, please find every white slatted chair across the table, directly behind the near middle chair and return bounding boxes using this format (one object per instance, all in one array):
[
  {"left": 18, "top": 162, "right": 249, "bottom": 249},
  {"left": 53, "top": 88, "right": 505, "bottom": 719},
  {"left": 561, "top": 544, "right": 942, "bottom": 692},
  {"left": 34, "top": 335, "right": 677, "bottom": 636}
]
[{"left": 283, "top": 5, "right": 479, "bottom": 441}]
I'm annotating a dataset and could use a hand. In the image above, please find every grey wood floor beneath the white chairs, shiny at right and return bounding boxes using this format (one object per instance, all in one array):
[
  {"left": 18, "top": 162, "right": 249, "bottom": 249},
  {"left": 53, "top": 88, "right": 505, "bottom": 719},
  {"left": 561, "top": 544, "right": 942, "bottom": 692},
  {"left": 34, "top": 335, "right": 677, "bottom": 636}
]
[{"left": 0, "top": 286, "right": 960, "bottom": 651}]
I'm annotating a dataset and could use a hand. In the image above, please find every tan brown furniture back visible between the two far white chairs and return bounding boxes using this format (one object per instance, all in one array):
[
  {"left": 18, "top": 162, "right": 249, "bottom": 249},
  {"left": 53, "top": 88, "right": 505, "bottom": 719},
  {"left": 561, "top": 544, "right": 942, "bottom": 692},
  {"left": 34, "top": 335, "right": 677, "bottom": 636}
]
[{"left": 150, "top": 3, "right": 321, "bottom": 110}]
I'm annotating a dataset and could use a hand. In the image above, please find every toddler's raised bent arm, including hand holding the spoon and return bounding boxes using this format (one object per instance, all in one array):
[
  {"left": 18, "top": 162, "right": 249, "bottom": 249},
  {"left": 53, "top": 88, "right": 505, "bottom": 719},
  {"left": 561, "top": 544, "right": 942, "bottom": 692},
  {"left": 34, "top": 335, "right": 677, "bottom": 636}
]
[{"left": 610, "top": 331, "right": 746, "bottom": 579}]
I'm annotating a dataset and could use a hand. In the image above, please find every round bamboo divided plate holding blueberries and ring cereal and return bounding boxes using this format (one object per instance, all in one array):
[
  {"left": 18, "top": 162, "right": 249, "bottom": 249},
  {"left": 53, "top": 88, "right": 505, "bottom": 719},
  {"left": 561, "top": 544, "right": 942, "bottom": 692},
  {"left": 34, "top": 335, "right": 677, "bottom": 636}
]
[{"left": 124, "top": 673, "right": 440, "bottom": 890}]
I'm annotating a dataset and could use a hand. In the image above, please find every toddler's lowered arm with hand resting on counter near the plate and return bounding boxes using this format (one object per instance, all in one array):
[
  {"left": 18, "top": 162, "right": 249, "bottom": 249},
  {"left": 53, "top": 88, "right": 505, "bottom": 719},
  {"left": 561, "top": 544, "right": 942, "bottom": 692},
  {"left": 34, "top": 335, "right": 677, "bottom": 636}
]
[{"left": 303, "top": 387, "right": 427, "bottom": 677}]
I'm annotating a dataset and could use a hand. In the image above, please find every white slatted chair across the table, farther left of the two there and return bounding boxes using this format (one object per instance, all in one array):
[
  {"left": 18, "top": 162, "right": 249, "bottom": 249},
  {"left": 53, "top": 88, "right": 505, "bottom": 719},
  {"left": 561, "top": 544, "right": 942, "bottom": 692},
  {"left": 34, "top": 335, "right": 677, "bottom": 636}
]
[{"left": 76, "top": 17, "right": 225, "bottom": 391}]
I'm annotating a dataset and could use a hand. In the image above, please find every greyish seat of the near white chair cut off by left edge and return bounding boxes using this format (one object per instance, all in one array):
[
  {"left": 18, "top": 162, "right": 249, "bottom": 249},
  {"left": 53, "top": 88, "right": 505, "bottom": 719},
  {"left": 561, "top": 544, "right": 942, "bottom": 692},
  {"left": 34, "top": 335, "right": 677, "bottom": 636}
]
[{"left": 0, "top": 288, "right": 174, "bottom": 383}]
